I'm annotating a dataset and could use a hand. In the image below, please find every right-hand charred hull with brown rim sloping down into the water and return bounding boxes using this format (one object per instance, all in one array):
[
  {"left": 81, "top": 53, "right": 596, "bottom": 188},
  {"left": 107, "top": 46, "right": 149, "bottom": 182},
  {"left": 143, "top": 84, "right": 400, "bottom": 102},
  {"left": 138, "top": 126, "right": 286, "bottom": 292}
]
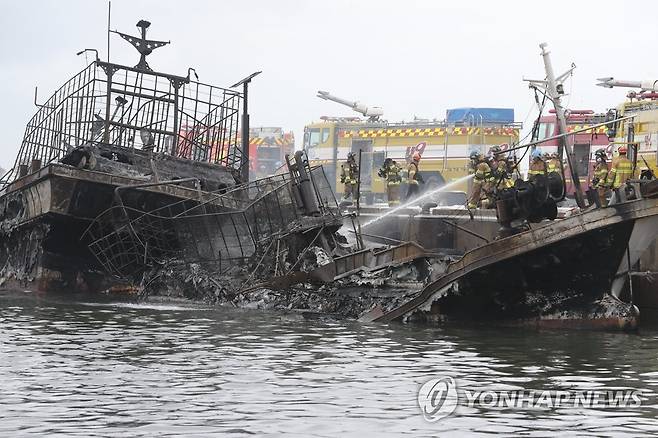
[{"left": 376, "top": 195, "right": 658, "bottom": 329}]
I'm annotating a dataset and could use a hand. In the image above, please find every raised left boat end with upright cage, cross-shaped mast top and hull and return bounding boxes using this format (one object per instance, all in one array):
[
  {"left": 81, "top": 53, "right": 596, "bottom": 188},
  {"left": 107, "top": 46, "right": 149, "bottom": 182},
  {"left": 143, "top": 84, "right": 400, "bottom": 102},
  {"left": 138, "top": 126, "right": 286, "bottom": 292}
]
[{"left": 0, "top": 20, "right": 247, "bottom": 292}]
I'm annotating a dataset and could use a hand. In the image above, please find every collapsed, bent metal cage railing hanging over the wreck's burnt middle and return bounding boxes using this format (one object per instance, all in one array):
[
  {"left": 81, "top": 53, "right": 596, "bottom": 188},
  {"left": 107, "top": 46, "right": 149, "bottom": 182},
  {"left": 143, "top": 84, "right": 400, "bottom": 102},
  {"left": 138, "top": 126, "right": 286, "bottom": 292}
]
[{"left": 83, "top": 166, "right": 341, "bottom": 279}]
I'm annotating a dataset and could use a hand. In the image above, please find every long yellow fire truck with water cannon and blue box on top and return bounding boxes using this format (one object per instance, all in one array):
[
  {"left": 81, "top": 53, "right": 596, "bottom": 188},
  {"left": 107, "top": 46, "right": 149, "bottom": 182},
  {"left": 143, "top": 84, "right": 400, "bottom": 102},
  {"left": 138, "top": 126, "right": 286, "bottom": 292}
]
[{"left": 304, "top": 91, "right": 521, "bottom": 203}]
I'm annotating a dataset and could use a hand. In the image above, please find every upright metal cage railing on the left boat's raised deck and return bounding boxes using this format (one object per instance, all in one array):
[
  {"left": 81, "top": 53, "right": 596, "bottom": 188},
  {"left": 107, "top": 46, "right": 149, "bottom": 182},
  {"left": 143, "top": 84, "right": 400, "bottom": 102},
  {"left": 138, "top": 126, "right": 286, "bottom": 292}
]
[{"left": 0, "top": 60, "right": 243, "bottom": 184}]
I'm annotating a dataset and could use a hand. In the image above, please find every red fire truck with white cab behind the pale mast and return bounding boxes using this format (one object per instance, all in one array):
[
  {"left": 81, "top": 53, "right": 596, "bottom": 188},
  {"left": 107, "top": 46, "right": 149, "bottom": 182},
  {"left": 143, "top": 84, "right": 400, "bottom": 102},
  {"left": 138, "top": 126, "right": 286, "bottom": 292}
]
[{"left": 536, "top": 110, "right": 612, "bottom": 193}]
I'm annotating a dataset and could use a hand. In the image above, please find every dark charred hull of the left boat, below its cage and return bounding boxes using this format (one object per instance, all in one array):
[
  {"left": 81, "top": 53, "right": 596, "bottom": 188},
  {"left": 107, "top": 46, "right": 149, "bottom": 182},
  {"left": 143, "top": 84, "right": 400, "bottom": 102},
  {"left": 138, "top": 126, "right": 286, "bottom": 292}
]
[{"left": 0, "top": 164, "right": 236, "bottom": 292}]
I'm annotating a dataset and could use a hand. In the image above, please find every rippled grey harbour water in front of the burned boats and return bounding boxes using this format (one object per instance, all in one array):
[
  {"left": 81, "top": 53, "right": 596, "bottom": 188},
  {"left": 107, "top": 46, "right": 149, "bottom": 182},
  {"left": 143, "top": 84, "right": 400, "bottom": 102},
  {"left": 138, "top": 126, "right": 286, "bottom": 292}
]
[{"left": 0, "top": 291, "right": 658, "bottom": 437}]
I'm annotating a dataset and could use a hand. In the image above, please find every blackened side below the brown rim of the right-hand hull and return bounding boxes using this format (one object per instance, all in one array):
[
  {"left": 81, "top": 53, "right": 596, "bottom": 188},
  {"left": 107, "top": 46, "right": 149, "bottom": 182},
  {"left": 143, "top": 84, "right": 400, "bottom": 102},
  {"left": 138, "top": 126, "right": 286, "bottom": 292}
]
[{"left": 438, "top": 221, "right": 633, "bottom": 319}]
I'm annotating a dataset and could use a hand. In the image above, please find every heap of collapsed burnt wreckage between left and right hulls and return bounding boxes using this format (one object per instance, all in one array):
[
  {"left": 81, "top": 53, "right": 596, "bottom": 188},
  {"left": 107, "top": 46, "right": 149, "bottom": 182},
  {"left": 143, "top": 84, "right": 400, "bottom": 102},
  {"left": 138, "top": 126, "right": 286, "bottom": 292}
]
[{"left": 83, "top": 152, "right": 443, "bottom": 317}]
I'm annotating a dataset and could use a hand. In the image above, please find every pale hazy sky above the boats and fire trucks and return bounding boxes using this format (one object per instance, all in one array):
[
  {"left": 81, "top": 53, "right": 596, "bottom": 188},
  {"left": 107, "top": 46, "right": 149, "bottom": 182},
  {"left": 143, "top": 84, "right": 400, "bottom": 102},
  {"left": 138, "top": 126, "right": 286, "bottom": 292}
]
[{"left": 0, "top": 0, "right": 658, "bottom": 167}]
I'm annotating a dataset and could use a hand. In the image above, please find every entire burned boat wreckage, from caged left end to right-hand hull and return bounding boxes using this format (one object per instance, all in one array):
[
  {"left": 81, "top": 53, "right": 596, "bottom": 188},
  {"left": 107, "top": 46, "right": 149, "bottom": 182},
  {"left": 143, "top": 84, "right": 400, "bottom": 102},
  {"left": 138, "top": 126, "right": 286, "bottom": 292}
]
[{"left": 0, "top": 20, "right": 658, "bottom": 328}]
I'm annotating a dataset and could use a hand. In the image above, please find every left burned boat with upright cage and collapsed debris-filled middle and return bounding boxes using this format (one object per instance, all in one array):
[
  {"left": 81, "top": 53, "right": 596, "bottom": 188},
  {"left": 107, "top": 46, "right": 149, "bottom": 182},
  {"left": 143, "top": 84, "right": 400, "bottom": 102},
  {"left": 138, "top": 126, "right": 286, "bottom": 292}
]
[{"left": 0, "top": 20, "right": 430, "bottom": 316}]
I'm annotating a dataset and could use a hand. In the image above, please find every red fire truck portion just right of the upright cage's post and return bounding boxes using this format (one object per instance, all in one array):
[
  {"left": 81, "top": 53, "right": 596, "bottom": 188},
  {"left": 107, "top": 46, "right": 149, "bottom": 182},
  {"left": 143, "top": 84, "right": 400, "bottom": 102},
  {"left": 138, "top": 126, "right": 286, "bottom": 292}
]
[{"left": 249, "top": 127, "right": 295, "bottom": 180}]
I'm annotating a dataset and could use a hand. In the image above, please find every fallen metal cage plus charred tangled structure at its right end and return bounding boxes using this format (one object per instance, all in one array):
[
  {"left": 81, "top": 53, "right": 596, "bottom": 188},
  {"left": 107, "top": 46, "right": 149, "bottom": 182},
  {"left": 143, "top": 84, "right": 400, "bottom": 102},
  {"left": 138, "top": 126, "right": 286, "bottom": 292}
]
[{"left": 84, "top": 154, "right": 342, "bottom": 280}]
